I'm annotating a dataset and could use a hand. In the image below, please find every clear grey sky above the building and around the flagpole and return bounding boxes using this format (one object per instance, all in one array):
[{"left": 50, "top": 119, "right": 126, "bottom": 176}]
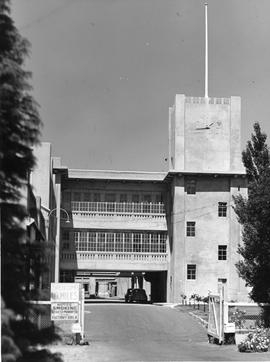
[{"left": 11, "top": 0, "right": 270, "bottom": 171}]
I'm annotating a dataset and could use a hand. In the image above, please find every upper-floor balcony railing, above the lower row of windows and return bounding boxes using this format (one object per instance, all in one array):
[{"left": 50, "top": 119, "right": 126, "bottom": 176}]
[{"left": 71, "top": 201, "right": 165, "bottom": 217}]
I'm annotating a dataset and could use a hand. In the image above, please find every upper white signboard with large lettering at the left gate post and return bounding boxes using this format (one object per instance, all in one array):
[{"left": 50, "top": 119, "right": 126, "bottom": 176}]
[{"left": 51, "top": 283, "right": 81, "bottom": 303}]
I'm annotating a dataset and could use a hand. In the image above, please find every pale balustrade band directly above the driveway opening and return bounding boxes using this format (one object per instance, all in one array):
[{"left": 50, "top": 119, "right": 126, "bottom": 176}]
[{"left": 61, "top": 251, "right": 168, "bottom": 263}]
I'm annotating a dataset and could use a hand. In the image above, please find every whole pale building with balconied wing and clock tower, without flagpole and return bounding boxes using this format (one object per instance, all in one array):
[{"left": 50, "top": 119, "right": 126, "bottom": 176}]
[{"left": 33, "top": 95, "right": 247, "bottom": 302}]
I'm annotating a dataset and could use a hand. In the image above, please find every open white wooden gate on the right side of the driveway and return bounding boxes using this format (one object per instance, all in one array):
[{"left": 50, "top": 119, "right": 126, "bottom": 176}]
[{"left": 207, "top": 286, "right": 224, "bottom": 344}]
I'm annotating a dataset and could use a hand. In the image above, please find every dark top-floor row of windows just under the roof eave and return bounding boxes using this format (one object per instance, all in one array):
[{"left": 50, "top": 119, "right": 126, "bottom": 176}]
[{"left": 63, "top": 191, "right": 162, "bottom": 203}]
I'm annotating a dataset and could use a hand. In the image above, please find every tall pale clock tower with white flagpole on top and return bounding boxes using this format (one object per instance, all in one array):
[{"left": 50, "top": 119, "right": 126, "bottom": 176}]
[{"left": 167, "top": 4, "right": 247, "bottom": 302}]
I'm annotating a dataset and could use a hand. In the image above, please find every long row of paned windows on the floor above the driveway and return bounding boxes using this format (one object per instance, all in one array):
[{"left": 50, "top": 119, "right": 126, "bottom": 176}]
[{"left": 62, "top": 231, "right": 167, "bottom": 253}]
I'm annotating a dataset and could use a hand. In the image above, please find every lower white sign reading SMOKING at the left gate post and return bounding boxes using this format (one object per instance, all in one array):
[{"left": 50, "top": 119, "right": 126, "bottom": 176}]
[{"left": 51, "top": 302, "right": 79, "bottom": 321}]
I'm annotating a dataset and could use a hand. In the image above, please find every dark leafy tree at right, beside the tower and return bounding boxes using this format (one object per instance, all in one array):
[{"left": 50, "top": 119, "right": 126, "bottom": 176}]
[{"left": 234, "top": 123, "right": 270, "bottom": 303}]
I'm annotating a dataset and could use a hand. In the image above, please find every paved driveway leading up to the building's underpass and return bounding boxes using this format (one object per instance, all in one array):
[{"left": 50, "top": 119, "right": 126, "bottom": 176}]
[{"left": 50, "top": 303, "right": 270, "bottom": 362}]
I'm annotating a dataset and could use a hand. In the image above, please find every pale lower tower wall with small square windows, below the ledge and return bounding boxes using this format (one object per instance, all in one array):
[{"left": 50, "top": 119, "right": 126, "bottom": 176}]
[{"left": 168, "top": 175, "right": 247, "bottom": 302}]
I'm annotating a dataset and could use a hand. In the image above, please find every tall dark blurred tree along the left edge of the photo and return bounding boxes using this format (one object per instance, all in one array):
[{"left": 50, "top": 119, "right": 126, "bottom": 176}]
[{"left": 0, "top": 0, "right": 62, "bottom": 361}]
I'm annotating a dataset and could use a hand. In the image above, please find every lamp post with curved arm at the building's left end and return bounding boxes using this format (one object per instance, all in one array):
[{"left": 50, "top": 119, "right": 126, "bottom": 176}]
[{"left": 41, "top": 205, "right": 70, "bottom": 283}]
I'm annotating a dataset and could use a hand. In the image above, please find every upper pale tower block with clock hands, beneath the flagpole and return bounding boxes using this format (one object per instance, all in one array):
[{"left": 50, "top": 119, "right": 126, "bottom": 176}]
[{"left": 169, "top": 94, "right": 243, "bottom": 172}]
